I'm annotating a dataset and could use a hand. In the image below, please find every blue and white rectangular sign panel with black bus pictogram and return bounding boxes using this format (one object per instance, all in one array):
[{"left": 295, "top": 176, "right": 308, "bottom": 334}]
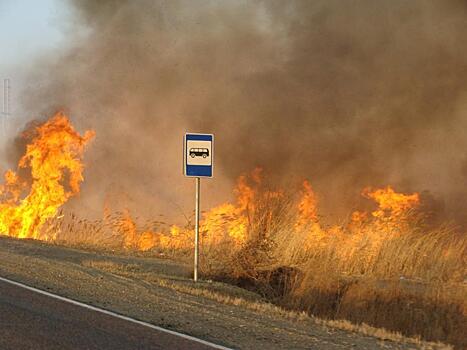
[{"left": 183, "top": 133, "right": 214, "bottom": 177}]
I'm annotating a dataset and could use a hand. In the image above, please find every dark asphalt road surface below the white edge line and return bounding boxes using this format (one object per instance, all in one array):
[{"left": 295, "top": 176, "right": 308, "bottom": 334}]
[{"left": 0, "top": 281, "right": 227, "bottom": 350}]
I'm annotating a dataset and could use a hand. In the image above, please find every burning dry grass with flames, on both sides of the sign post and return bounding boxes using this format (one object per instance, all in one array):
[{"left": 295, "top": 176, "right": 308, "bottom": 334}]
[{"left": 43, "top": 172, "right": 467, "bottom": 348}]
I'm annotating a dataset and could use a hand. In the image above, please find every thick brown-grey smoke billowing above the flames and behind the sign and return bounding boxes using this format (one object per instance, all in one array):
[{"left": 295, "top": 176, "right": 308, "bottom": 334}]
[{"left": 3, "top": 0, "right": 467, "bottom": 224}]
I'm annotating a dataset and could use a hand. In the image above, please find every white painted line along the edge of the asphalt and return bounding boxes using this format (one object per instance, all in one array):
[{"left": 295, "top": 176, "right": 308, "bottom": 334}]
[{"left": 0, "top": 277, "right": 233, "bottom": 350}]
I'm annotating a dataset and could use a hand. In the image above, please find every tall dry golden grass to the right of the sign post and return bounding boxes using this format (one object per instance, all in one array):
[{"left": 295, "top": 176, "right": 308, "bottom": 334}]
[{"left": 193, "top": 182, "right": 467, "bottom": 348}]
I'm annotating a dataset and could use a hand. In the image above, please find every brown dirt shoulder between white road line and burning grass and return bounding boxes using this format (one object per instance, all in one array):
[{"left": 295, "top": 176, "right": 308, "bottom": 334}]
[{"left": 0, "top": 237, "right": 450, "bottom": 349}]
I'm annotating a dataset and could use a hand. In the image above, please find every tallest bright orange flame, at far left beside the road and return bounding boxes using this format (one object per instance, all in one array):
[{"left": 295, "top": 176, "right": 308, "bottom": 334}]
[{"left": 0, "top": 113, "right": 94, "bottom": 240}]
